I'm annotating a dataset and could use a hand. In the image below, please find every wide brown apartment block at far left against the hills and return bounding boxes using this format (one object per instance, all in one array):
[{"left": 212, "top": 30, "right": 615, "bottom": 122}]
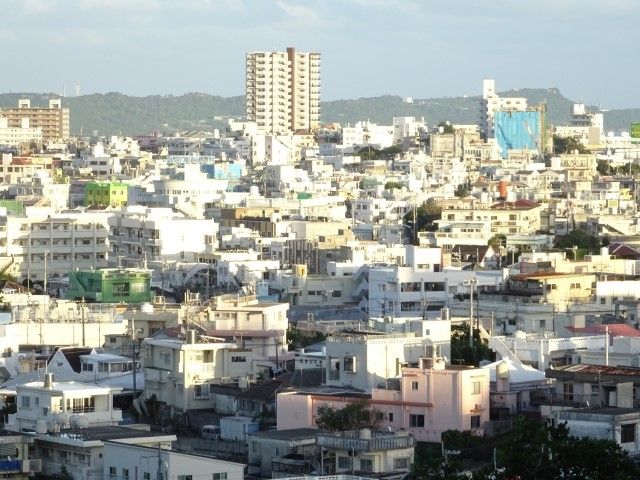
[{"left": 0, "top": 98, "right": 69, "bottom": 143}]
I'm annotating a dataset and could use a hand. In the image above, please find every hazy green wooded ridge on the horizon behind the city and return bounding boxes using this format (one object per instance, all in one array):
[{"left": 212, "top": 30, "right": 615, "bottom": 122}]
[{"left": 0, "top": 88, "right": 640, "bottom": 135}]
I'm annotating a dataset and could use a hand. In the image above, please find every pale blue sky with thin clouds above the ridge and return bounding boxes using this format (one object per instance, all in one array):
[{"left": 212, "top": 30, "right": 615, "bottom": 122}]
[{"left": 0, "top": 0, "right": 640, "bottom": 108}]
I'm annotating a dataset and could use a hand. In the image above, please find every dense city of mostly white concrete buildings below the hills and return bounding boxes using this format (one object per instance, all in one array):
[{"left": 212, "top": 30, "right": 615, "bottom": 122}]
[{"left": 0, "top": 4, "right": 640, "bottom": 480}]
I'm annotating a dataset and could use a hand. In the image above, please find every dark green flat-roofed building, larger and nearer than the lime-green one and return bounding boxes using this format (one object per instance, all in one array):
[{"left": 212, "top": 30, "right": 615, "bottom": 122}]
[{"left": 65, "top": 268, "right": 153, "bottom": 303}]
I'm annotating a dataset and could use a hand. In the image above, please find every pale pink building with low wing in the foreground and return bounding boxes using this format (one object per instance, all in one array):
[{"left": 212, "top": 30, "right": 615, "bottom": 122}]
[{"left": 276, "top": 358, "right": 489, "bottom": 442}]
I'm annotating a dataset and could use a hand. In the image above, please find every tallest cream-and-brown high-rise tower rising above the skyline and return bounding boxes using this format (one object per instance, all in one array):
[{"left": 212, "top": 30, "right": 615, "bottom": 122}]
[{"left": 246, "top": 48, "right": 320, "bottom": 134}]
